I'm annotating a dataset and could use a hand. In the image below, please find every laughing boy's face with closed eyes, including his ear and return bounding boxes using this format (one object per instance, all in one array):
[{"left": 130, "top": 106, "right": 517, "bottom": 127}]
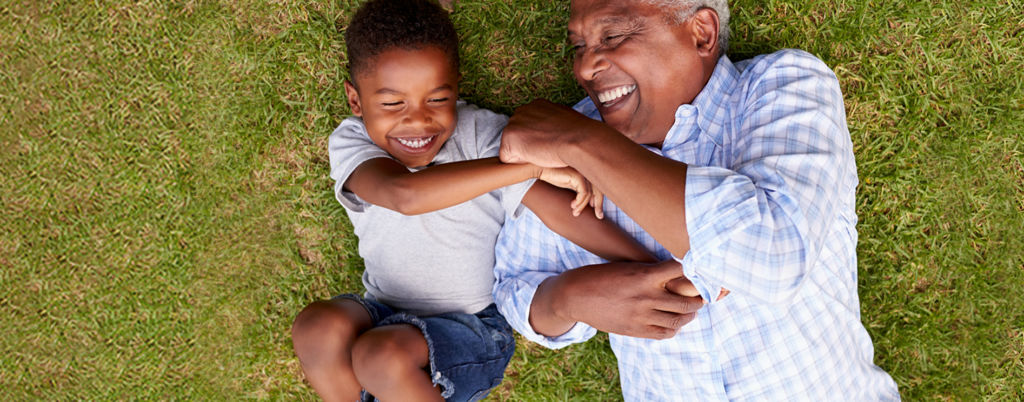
[{"left": 345, "top": 46, "right": 459, "bottom": 168}]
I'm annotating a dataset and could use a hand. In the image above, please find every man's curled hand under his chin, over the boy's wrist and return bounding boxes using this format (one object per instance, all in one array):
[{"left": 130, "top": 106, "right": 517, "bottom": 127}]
[{"left": 499, "top": 99, "right": 603, "bottom": 168}]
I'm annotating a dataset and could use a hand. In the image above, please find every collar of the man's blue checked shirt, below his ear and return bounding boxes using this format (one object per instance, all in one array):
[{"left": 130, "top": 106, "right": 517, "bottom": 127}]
[{"left": 663, "top": 54, "right": 739, "bottom": 147}]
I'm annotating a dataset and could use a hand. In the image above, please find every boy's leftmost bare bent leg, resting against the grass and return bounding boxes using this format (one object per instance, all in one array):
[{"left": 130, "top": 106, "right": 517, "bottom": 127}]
[{"left": 292, "top": 299, "right": 373, "bottom": 401}]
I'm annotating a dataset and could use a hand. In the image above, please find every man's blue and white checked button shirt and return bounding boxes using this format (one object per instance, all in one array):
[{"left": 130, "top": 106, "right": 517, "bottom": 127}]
[{"left": 495, "top": 50, "right": 899, "bottom": 401}]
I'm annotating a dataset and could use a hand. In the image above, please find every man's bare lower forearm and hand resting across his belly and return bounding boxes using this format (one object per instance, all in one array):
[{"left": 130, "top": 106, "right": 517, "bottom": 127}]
[{"left": 530, "top": 260, "right": 705, "bottom": 340}]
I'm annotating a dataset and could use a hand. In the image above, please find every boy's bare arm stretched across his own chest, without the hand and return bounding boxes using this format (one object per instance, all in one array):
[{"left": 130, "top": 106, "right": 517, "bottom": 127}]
[{"left": 345, "top": 157, "right": 542, "bottom": 215}]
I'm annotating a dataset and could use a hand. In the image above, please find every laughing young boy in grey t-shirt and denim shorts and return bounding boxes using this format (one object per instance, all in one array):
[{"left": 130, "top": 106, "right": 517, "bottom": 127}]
[{"left": 292, "top": 0, "right": 652, "bottom": 401}]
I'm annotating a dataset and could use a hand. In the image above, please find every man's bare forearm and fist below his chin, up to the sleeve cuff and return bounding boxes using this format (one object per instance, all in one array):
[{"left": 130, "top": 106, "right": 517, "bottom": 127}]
[{"left": 502, "top": 100, "right": 689, "bottom": 256}]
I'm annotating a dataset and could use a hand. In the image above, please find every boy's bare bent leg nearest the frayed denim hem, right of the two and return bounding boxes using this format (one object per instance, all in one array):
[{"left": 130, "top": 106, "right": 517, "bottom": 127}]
[{"left": 352, "top": 324, "right": 443, "bottom": 401}]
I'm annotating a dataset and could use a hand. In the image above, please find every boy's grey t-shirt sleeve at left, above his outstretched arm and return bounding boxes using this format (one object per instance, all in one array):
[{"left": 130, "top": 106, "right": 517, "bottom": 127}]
[{"left": 327, "top": 118, "right": 391, "bottom": 212}]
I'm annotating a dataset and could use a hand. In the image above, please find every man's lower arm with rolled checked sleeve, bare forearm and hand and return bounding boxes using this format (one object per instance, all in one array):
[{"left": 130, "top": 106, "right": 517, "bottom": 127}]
[{"left": 494, "top": 206, "right": 703, "bottom": 341}]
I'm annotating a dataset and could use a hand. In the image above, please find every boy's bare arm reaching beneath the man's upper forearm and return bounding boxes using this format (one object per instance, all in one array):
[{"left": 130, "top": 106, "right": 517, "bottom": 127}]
[{"left": 522, "top": 181, "right": 656, "bottom": 263}]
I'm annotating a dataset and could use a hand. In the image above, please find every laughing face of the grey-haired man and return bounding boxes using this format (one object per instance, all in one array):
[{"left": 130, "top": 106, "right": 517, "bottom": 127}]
[{"left": 568, "top": 0, "right": 709, "bottom": 144}]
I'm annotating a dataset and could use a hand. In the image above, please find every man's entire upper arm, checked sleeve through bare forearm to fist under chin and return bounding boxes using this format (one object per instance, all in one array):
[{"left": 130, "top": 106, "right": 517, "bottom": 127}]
[{"left": 502, "top": 52, "right": 856, "bottom": 303}]
